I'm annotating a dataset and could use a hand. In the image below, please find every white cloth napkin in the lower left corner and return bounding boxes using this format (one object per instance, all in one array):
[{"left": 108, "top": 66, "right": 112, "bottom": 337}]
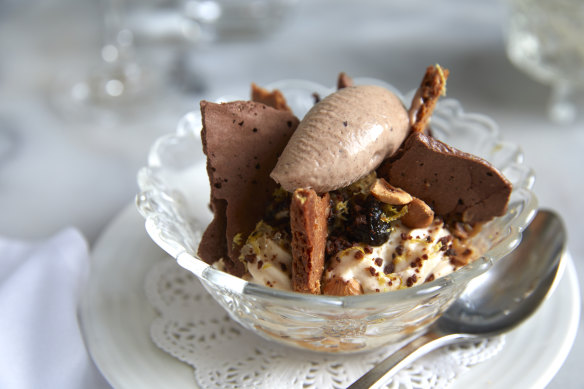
[{"left": 0, "top": 228, "right": 110, "bottom": 389}]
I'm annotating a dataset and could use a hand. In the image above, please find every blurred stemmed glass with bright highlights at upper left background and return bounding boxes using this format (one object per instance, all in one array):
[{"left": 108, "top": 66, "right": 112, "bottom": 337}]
[{"left": 51, "top": 0, "right": 185, "bottom": 126}]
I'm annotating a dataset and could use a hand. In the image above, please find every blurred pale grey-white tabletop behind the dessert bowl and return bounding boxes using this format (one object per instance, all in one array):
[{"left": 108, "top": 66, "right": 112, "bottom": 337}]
[{"left": 0, "top": 0, "right": 584, "bottom": 388}]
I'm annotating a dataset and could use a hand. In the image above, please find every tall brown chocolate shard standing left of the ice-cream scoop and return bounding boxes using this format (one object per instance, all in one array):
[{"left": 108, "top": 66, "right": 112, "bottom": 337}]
[{"left": 198, "top": 101, "right": 298, "bottom": 275}]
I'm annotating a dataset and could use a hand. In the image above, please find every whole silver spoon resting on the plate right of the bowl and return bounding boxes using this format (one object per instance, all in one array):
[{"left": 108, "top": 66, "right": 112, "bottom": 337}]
[{"left": 348, "top": 210, "right": 566, "bottom": 389}]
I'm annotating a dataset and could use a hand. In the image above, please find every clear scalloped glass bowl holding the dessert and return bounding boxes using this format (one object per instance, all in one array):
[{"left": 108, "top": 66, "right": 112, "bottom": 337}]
[{"left": 136, "top": 78, "right": 537, "bottom": 353}]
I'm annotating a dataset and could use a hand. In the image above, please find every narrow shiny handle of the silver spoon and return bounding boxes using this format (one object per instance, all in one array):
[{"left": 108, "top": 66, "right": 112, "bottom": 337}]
[{"left": 347, "top": 329, "right": 472, "bottom": 389}]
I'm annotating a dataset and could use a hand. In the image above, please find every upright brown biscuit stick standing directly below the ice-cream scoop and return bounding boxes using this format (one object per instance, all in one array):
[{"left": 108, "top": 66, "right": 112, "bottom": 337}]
[{"left": 290, "top": 188, "right": 330, "bottom": 294}]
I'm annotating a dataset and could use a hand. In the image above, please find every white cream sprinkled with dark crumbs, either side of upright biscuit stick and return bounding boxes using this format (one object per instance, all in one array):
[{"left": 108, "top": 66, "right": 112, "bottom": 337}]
[{"left": 236, "top": 220, "right": 456, "bottom": 293}]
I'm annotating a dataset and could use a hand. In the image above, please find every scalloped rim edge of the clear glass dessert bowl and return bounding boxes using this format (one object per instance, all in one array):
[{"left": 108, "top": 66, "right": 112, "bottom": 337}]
[{"left": 138, "top": 77, "right": 537, "bottom": 308}]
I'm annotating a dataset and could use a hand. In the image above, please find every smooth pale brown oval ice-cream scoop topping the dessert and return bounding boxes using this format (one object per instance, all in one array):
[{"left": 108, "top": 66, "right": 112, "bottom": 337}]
[{"left": 271, "top": 85, "right": 410, "bottom": 193}]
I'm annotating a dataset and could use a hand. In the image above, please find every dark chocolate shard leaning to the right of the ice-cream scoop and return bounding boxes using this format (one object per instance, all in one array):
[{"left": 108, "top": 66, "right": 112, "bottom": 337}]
[{"left": 378, "top": 132, "right": 512, "bottom": 224}]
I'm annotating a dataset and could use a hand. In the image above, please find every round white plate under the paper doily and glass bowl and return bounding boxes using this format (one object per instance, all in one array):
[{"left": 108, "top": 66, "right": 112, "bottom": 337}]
[{"left": 80, "top": 202, "right": 580, "bottom": 389}]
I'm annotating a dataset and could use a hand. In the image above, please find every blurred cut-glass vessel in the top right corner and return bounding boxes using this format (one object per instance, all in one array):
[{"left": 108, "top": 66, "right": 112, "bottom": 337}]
[{"left": 506, "top": 0, "right": 584, "bottom": 123}]
